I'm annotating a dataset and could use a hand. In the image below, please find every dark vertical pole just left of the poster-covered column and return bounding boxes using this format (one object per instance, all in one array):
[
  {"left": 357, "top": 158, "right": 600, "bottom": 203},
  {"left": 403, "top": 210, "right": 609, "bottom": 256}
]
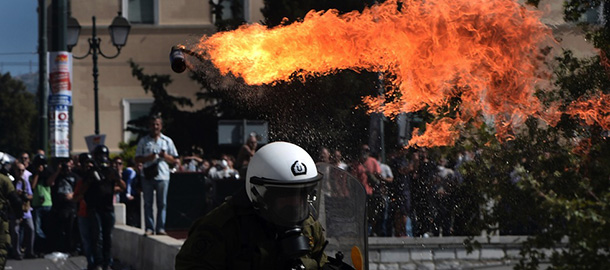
[{"left": 38, "top": 0, "right": 49, "bottom": 151}]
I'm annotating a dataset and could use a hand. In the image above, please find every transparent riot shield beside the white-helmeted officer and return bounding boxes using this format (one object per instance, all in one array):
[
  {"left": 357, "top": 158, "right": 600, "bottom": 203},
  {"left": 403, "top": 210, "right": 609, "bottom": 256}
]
[{"left": 314, "top": 163, "right": 369, "bottom": 270}]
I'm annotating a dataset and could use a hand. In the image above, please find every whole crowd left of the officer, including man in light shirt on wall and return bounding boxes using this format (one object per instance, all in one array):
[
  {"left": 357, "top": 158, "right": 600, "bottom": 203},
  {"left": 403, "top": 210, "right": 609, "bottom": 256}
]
[{"left": 2, "top": 115, "right": 246, "bottom": 269}]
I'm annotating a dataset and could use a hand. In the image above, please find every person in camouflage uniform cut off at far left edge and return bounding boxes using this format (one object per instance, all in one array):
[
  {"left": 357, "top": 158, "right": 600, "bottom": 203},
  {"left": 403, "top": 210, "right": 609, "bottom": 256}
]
[{"left": 0, "top": 174, "right": 15, "bottom": 269}]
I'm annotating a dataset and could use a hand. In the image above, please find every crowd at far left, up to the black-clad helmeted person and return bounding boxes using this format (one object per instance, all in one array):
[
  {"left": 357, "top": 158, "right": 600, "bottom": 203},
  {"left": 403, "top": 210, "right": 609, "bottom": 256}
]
[{"left": 2, "top": 145, "right": 132, "bottom": 269}]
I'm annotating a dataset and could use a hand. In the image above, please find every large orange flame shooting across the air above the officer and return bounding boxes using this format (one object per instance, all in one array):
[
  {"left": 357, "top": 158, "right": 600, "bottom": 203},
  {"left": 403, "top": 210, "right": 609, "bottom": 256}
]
[{"left": 194, "top": 0, "right": 607, "bottom": 146}]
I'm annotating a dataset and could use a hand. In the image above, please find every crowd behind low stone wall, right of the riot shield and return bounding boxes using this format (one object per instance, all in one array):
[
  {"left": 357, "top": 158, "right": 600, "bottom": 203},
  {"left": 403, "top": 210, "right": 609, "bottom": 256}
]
[{"left": 317, "top": 145, "right": 478, "bottom": 237}]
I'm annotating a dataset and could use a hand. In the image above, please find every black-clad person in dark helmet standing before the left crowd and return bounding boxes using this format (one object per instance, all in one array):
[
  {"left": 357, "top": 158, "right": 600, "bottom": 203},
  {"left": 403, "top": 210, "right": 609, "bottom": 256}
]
[{"left": 73, "top": 145, "right": 125, "bottom": 269}]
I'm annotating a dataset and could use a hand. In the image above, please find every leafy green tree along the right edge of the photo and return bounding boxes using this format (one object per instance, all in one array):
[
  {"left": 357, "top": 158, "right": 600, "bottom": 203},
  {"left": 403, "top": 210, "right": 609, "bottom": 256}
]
[{"left": 458, "top": 0, "right": 610, "bottom": 269}]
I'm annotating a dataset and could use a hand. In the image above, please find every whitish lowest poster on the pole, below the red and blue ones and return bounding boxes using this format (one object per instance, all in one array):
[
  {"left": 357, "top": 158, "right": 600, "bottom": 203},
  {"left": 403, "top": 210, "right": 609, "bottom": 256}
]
[{"left": 49, "top": 105, "right": 70, "bottom": 158}]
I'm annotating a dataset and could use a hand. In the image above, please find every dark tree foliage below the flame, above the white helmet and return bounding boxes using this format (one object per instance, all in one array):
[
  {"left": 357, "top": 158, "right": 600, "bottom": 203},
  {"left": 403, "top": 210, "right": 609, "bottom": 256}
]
[{"left": 128, "top": 59, "right": 380, "bottom": 160}]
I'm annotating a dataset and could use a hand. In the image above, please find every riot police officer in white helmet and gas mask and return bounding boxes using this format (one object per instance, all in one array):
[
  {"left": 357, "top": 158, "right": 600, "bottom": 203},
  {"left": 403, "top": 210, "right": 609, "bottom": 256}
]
[{"left": 175, "top": 142, "right": 328, "bottom": 270}]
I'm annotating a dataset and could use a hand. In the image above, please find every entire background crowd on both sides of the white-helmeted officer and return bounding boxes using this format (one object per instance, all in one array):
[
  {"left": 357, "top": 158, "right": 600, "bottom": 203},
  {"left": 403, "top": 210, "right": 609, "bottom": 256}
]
[{"left": 4, "top": 113, "right": 498, "bottom": 269}]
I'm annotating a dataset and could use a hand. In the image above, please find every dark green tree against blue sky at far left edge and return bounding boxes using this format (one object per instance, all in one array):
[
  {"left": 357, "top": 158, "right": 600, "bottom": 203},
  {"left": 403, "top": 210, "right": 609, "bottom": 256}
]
[{"left": 0, "top": 73, "right": 37, "bottom": 155}]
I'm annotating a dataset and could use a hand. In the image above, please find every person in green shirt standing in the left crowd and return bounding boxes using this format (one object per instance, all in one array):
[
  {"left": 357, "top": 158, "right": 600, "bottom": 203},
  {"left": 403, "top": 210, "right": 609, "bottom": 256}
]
[{"left": 30, "top": 154, "right": 53, "bottom": 253}]
